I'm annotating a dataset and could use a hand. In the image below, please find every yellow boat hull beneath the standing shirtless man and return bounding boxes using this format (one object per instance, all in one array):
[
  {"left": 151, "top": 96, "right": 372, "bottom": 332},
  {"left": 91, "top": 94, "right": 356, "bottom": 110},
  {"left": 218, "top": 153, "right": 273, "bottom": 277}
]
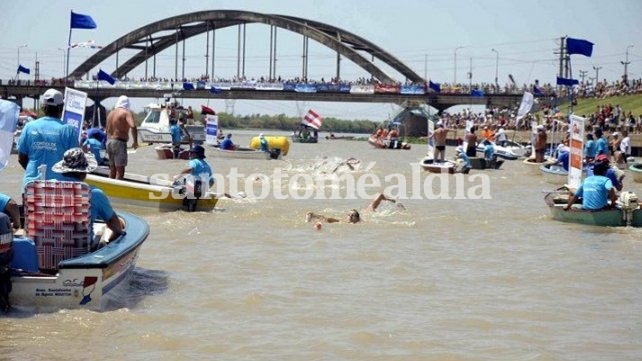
[{"left": 85, "top": 168, "right": 218, "bottom": 212}]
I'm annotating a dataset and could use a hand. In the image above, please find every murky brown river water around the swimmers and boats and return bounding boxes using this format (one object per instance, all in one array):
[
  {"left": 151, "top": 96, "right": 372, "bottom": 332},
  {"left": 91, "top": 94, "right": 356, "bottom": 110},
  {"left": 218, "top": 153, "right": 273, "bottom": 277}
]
[{"left": 0, "top": 132, "right": 642, "bottom": 361}]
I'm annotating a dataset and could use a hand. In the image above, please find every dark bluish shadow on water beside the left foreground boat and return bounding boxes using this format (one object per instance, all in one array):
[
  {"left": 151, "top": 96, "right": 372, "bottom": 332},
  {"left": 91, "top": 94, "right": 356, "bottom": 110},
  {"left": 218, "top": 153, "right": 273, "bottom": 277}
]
[{"left": 103, "top": 267, "right": 169, "bottom": 311}]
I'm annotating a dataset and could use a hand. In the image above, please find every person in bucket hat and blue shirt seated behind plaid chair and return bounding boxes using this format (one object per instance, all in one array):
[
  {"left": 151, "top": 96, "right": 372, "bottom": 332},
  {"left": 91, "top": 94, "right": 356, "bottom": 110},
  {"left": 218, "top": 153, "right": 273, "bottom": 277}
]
[{"left": 51, "top": 148, "right": 125, "bottom": 241}]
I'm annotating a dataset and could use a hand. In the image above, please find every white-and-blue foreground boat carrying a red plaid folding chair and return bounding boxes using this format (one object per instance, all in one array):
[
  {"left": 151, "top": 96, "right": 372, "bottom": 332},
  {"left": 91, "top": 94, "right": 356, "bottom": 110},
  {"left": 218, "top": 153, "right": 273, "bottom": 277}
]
[{"left": 0, "top": 181, "right": 149, "bottom": 312}]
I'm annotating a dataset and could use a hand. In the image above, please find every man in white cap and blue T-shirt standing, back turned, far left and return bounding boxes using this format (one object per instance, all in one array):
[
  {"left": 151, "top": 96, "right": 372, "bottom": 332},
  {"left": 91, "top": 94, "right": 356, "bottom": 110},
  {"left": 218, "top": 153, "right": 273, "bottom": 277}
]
[{"left": 18, "top": 89, "right": 79, "bottom": 189}]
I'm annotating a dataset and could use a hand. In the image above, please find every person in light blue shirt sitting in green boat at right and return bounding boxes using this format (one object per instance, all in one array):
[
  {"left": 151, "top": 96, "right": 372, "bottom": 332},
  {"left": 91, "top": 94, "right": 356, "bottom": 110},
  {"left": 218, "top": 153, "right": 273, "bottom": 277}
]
[{"left": 564, "top": 161, "right": 617, "bottom": 211}]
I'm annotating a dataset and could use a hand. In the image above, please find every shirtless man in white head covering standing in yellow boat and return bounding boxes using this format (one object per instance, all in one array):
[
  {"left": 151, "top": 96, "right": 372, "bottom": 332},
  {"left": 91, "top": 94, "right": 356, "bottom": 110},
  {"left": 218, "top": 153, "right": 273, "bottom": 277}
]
[{"left": 105, "top": 95, "right": 138, "bottom": 179}]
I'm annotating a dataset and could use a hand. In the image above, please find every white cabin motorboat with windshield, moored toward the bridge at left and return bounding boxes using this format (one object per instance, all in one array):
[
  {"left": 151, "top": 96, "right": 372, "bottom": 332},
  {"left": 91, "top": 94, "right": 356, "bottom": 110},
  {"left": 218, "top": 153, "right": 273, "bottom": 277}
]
[{"left": 137, "top": 103, "right": 205, "bottom": 144}]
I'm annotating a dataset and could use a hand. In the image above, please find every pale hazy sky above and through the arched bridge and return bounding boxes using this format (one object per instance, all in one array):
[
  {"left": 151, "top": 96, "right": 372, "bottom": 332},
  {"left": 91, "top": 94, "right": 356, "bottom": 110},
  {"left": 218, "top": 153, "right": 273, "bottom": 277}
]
[{"left": 0, "top": 0, "right": 642, "bottom": 121}]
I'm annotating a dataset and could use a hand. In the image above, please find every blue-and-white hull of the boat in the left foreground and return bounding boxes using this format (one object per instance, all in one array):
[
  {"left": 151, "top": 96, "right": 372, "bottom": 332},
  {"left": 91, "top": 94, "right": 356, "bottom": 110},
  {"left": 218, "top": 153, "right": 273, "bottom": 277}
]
[{"left": 9, "top": 212, "right": 149, "bottom": 311}]
